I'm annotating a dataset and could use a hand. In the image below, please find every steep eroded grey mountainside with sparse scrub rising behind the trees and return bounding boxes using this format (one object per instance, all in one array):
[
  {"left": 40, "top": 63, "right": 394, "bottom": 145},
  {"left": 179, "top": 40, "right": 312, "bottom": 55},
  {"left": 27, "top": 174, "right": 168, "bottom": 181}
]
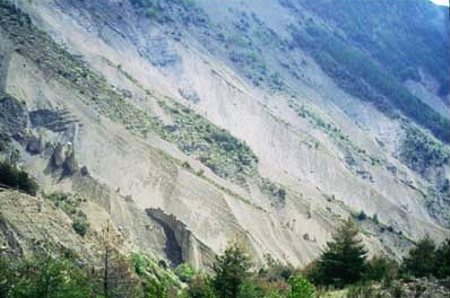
[{"left": 0, "top": 0, "right": 450, "bottom": 266}]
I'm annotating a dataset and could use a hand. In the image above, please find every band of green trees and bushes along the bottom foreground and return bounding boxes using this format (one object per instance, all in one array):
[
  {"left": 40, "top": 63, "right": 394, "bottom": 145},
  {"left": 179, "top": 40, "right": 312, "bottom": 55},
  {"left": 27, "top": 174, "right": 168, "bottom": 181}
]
[{"left": 0, "top": 219, "right": 450, "bottom": 298}]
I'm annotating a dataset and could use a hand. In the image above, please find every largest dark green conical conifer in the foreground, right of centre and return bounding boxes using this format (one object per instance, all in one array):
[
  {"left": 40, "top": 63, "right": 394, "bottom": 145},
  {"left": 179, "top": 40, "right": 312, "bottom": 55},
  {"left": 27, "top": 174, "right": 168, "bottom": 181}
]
[{"left": 313, "top": 218, "right": 367, "bottom": 287}]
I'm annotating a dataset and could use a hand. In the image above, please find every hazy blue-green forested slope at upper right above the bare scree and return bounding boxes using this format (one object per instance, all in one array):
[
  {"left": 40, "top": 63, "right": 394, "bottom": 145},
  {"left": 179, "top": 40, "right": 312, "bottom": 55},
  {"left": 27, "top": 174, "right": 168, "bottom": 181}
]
[{"left": 288, "top": 1, "right": 450, "bottom": 143}]
